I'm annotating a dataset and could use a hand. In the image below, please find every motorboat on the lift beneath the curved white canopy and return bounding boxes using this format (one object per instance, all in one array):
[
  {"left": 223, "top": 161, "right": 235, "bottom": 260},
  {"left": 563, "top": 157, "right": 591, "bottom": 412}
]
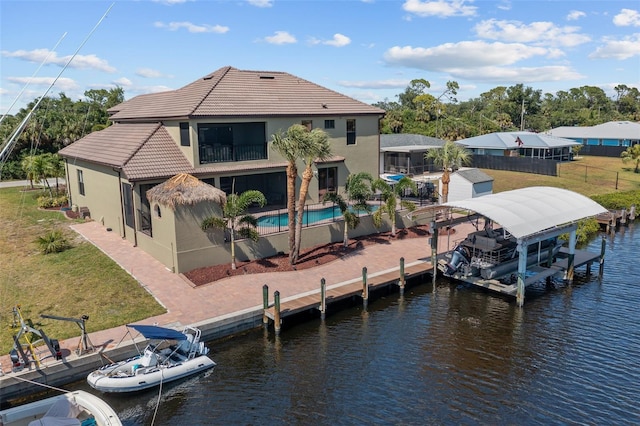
[{"left": 438, "top": 221, "right": 562, "bottom": 284}]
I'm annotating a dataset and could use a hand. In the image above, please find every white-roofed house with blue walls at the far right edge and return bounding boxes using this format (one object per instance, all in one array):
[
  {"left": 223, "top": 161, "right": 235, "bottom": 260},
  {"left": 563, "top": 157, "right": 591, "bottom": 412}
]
[{"left": 547, "top": 121, "right": 640, "bottom": 157}]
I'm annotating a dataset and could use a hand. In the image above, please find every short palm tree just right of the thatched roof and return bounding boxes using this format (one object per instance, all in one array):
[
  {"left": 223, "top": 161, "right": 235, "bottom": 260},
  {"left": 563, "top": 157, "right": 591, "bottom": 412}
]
[{"left": 200, "top": 190, "right": 267, "bottom": 269}]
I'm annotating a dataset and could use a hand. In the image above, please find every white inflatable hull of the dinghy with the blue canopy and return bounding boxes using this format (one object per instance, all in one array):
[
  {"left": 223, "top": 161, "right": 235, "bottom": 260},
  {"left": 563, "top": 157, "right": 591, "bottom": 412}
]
[{"left": 87, "top": 355, "right": 216, "bottom": 392}]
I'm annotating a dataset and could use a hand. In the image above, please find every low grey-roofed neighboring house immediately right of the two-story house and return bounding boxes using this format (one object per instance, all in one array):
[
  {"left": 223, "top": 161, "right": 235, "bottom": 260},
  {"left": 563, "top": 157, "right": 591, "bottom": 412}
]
[{"left": 380, "top": 133, "right": 445, "bottom": 175}]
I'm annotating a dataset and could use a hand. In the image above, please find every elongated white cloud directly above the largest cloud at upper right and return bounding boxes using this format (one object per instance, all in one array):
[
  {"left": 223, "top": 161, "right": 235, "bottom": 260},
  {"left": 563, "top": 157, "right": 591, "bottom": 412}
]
[{"left": 474, "top": 19, "right": 591, "bottom": 46}]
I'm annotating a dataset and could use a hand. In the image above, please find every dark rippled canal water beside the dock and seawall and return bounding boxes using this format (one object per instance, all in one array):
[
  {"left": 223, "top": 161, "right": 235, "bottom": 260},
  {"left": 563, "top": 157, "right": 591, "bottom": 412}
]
[{"left": 71, "top": 224, "right": 640, "bottom": 425}]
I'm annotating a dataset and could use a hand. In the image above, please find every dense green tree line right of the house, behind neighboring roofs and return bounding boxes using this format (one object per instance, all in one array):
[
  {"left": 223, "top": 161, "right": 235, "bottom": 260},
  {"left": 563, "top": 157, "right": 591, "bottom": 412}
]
[{"left": 374, "top": 79, "right": 640, "bottom": 141}]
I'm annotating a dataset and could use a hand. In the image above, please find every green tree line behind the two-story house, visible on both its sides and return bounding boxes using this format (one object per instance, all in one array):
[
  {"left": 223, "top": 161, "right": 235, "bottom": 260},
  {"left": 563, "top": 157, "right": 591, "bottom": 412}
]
[{"left": 0, "top": 79, "right": 640, "bottom": 180}]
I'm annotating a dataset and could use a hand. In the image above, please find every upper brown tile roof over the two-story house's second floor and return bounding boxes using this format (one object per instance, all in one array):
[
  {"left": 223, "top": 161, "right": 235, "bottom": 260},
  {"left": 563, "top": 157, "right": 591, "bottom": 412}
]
[{"left": 109, "top": 67, "right": 385, "bottom": 121}]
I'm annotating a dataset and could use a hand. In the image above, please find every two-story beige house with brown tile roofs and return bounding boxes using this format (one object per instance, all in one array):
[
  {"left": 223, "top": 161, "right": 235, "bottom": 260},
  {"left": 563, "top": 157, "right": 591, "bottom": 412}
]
[{"left": 60, "top": 67, "right": 384, "bottom": 272}]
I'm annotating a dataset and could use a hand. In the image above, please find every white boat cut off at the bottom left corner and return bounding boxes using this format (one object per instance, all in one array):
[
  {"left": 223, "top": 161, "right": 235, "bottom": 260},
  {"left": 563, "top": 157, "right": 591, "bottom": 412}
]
[{"left": 0, "top": 390, "right": 122, "bottom": 426}]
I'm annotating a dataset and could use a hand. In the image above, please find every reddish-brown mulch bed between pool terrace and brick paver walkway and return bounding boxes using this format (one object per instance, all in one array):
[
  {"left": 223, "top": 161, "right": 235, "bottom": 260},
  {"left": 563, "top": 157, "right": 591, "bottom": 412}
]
[{"left": 184, "top": 225, "right": 429, "bottom": 286}]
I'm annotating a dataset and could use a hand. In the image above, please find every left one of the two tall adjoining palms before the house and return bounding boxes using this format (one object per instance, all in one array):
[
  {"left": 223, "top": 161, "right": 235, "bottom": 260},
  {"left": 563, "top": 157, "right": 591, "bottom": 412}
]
[{"left": 271, "top": 124, "right": 308, "bottom": 261}]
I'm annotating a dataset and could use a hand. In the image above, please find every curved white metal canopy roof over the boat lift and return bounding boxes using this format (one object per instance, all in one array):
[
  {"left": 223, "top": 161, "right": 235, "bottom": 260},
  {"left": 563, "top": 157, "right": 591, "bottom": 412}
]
[{"left": 444, "top": 186, "right": 607, "bottom": 238}]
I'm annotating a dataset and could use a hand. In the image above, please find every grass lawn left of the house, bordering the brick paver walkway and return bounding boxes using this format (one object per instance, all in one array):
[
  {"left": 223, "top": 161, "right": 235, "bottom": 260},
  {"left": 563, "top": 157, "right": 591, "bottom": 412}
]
[{"left": 0, "top": 188, "right": 165, "bottom": 354}]
